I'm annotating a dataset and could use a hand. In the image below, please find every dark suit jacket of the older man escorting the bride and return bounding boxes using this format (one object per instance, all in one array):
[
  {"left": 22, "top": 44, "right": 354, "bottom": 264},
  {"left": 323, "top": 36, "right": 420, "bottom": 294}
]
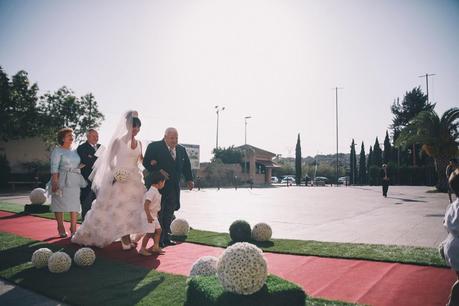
[{"left": 143, "top": 140, "right": 193, "bottom": 210}]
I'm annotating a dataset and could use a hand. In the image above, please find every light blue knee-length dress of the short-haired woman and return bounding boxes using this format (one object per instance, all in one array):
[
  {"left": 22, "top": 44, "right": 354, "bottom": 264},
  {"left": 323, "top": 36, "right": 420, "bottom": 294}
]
[{"left": 49, "top": 146, "right": 87, "bottom": 212}]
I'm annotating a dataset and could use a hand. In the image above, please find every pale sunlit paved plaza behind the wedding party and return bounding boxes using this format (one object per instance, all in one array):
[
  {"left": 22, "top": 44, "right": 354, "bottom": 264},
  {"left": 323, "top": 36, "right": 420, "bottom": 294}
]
[{"left": 0, "top": 186, "right": 448, "bottom": 247}]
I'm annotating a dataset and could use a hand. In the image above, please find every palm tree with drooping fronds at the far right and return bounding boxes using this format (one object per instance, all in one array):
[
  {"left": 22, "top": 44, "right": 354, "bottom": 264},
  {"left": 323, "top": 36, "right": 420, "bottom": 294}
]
[{"left": 395, "top": 107, "right": 459, "bottom": 192}]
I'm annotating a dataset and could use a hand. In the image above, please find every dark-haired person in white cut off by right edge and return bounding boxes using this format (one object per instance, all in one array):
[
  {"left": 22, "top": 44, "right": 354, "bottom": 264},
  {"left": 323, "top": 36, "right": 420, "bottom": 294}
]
[{"left": 440, "top": 169, "right": 459, "bottom": 306}]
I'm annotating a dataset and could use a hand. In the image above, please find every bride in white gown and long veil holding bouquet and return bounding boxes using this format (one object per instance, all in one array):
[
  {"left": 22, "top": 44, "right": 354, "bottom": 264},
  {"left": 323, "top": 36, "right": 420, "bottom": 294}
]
[{"left": 72, "top": 111, "right": 148, "bottom": 250}]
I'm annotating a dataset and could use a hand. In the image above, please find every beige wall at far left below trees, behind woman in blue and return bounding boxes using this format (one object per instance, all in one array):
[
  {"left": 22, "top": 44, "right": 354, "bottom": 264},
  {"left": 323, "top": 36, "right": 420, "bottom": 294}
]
[{"left": 0, "top": 137, "right": 49, "bottom": 173}]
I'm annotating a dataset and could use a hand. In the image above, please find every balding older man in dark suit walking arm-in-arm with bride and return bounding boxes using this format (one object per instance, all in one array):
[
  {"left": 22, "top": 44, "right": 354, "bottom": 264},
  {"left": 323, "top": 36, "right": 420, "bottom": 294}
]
[{"left": 143, "top": 127, "right": 194, "bottom": 247}]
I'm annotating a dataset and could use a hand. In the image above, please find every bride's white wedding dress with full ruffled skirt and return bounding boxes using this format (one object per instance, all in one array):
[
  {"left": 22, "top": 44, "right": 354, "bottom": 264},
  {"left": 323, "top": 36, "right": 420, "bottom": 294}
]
[{"left": 72, "top": 139, "right": 148, "bottom": 248}]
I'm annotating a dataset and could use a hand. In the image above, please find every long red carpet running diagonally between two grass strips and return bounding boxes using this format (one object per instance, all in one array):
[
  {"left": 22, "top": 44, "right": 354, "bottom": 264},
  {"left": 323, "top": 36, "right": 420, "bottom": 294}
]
[{"left": 0, "top": 211, "right": 455, "bottom": 306}]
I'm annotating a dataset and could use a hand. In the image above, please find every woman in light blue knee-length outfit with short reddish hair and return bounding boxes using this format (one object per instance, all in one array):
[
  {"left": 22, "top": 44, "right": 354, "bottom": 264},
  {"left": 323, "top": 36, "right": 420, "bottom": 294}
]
[{"left": 51, "top": 128, "right": 86, "bottom": 238}]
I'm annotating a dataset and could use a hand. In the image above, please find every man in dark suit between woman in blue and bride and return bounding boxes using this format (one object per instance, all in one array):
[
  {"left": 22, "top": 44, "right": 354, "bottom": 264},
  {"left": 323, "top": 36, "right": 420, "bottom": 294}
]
[{"left": 77, "top": 129, "right": 100, "bottom": 220}]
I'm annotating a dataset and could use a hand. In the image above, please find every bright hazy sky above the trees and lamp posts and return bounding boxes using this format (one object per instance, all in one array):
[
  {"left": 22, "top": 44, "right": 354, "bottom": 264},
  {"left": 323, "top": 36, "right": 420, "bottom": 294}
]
[{"left": 0, "top": 0, "right": 459, "bottom": 161}]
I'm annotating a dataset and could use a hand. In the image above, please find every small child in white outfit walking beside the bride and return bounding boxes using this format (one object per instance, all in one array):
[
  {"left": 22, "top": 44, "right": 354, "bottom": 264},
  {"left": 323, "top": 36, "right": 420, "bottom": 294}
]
[{"left": 139, "top": 171, "right": 166, "bottom": 256}]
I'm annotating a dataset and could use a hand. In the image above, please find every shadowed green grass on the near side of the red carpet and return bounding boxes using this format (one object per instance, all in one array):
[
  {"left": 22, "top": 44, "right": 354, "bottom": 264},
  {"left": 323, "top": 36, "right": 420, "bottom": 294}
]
[{"left": 0, "top": 232, "right": 355, "bottom": 306}]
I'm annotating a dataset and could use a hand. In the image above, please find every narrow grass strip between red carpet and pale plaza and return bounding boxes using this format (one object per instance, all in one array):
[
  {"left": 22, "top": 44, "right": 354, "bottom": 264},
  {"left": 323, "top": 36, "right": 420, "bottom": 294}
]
[{"left": 0, "top": 202, "right": 447, "bottom": 267}]
